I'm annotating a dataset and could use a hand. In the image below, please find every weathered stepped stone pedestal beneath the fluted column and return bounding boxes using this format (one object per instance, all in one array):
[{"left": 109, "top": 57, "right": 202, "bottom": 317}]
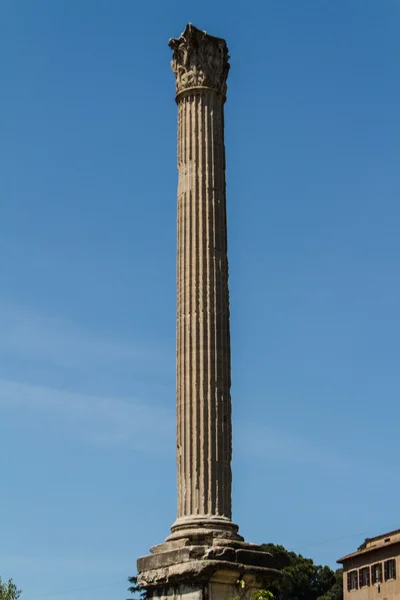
[{"left": 137, "top": 529, "right": 280, "bottom": 600}]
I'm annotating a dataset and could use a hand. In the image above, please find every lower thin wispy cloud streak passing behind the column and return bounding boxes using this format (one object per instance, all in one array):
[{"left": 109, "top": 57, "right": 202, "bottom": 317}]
[{"left": 0, "top": 379, "right": 348, "bottom": 469}]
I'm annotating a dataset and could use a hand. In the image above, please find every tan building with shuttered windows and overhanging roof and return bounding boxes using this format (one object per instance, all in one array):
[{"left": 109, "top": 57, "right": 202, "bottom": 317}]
[{"left": 337, "top": 529, "right": 400, "bottom": 600}]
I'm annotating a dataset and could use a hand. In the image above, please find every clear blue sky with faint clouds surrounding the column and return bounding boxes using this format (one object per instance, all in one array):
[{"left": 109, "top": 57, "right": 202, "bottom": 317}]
[{"left": 0, "top": 0, "right": 400, "bottom": 600}]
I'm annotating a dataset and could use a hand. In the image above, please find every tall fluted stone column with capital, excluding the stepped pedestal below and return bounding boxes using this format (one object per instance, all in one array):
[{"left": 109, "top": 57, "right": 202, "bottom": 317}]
[{"left": 169, "top": 24, "right": 237, "bottom": 537}]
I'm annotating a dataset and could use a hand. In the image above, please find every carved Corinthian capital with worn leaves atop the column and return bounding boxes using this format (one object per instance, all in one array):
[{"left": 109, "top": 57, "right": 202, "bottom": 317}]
[{"left": 168, "top": 23, "right": 229, "bottom": 98}]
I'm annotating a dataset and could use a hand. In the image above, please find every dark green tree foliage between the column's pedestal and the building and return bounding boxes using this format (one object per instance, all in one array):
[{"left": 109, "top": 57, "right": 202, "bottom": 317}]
[{"left": 262, "top": 544, "right": 343, "bottom": 600}]
